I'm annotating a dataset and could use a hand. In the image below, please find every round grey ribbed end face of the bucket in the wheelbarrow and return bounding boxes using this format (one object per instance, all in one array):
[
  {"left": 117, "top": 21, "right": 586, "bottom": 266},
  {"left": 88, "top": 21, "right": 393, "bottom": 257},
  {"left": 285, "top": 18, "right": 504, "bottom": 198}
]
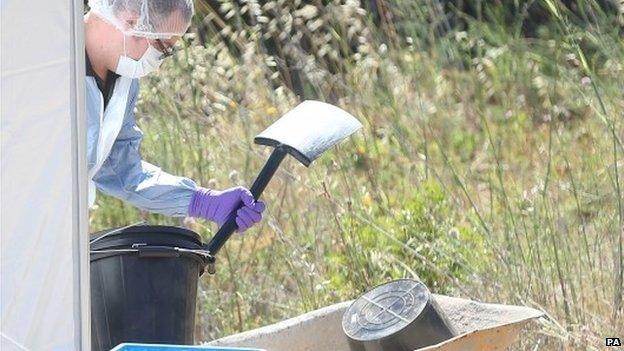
[{"left": 342, "top": 279, "right": 430, "bottom": 341}]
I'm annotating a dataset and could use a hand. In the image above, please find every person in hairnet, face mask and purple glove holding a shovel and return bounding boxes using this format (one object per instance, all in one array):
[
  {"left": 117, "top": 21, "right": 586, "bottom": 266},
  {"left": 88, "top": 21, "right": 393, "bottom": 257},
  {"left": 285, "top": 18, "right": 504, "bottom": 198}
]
[{"left": 84, "top": 0, "right": 265, "bottom": 232}]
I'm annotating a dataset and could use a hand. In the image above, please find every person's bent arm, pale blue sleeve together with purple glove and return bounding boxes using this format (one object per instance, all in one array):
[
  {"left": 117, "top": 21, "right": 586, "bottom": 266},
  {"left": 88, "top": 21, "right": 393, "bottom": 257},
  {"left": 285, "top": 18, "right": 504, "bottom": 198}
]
[{"left": 93, "top": 80, "right": 265, "bottom": 232}]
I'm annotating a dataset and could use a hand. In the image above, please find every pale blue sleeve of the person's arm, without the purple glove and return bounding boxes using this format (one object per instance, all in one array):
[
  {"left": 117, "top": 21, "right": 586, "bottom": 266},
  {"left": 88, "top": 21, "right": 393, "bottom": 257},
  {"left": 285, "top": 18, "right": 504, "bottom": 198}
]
[{"left": 93, "top": 80, "right": 199, "bottom": 216}]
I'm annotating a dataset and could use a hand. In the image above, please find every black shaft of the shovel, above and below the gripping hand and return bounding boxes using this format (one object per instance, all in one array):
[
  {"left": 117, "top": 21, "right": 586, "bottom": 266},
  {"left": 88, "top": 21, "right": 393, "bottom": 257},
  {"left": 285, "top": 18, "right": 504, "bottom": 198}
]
[{"left": 205, "top": 146, "right": 288, "bottom": 257}]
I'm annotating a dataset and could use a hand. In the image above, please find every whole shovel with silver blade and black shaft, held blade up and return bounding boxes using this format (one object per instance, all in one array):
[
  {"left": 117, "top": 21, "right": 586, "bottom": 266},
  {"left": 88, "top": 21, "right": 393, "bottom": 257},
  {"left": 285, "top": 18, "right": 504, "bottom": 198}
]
[{"left": 204, "top": 100, "right": 362, "bottom": 274}]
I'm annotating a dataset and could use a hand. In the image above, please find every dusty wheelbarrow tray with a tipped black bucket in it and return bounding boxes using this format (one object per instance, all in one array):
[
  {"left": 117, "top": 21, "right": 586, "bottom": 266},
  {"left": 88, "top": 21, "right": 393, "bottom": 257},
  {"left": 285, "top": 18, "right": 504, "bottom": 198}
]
[{"left": 208, "top": 294, "right": 543, "bottom": 351}]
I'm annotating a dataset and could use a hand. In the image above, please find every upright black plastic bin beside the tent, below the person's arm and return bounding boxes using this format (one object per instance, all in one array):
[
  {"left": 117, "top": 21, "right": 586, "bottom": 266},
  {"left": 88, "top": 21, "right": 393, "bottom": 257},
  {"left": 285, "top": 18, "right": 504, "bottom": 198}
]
[{"left": 90, "top": 225, "right": 208, "bottom": 351}]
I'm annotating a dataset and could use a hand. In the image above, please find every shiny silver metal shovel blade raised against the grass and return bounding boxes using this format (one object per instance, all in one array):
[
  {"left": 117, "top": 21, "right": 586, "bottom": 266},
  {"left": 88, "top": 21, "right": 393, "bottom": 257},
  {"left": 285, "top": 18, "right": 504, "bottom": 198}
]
[{"left": 254, "top": 100, "right": 362, "bottom": 167}]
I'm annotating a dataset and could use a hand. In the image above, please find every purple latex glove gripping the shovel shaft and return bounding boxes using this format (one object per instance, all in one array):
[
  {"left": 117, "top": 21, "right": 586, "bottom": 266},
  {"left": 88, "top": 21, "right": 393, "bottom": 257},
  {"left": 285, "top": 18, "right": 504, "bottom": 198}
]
[{"left": 188, "top": 186, "right": 266, "bottom": 233}]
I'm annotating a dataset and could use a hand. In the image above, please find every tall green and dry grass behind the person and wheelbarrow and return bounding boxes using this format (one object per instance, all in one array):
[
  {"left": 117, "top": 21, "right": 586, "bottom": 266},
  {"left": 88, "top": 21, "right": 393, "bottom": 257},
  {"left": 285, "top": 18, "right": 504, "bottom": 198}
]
[{"left": 91, "top": 0, "right": 624, "bottom": 350}]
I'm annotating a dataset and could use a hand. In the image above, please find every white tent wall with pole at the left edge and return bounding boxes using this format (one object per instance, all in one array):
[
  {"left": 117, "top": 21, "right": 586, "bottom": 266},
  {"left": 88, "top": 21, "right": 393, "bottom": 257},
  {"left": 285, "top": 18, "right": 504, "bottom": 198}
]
[{"left": 0, "top": 0, "right": 90, "bottom": 351}]
